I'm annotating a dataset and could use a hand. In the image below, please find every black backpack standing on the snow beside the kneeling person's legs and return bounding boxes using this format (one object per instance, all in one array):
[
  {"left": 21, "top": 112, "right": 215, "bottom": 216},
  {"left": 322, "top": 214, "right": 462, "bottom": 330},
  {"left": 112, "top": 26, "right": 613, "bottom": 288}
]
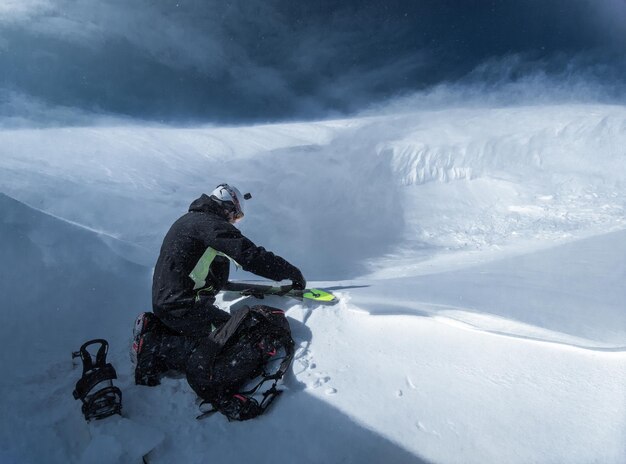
[{"left": 186, "top": 306, "right": 294, "bottom": 421}]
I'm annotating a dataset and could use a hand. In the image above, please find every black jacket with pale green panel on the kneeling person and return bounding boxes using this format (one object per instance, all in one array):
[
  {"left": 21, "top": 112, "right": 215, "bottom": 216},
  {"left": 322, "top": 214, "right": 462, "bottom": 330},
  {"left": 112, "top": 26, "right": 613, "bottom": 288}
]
[{"left": 152, "top": 194, "right": 299, "bottom": 315}]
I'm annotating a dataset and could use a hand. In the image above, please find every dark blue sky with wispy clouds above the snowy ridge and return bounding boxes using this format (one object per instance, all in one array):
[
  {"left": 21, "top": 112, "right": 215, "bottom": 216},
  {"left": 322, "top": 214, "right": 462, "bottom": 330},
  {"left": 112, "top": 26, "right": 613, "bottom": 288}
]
[{"left": 0, "top": 0, "right": 626, "bottom": 124}]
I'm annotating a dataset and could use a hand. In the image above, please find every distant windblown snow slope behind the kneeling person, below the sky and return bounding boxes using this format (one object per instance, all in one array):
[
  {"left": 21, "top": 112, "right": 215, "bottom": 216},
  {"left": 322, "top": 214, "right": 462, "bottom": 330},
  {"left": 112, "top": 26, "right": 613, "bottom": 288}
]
[{"left": 0, "top": 105, "right": 626, "bottom": 279}]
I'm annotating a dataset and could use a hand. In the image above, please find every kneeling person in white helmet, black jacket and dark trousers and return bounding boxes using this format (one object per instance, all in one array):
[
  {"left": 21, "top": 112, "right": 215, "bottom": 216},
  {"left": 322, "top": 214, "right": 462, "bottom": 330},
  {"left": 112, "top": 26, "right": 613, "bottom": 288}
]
[{"left": 131, "top": 184, "right": 306, "bottom": 385}]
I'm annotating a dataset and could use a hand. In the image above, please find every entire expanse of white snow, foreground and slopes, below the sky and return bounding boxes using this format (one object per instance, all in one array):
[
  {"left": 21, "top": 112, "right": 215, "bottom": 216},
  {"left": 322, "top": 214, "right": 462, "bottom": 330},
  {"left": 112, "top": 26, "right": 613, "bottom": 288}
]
[{"left": 0, "top": 105, "right": 626, "bottom": 463}]
